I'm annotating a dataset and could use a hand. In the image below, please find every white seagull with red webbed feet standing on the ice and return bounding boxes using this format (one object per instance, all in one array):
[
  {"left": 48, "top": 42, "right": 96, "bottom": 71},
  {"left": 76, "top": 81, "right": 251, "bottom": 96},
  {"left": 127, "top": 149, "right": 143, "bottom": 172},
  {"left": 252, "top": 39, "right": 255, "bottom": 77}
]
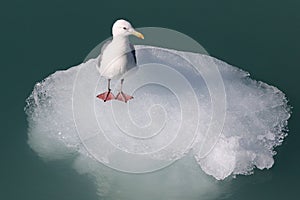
[{"left": 97, "top": 19, "right": 144, "bottom": 103}]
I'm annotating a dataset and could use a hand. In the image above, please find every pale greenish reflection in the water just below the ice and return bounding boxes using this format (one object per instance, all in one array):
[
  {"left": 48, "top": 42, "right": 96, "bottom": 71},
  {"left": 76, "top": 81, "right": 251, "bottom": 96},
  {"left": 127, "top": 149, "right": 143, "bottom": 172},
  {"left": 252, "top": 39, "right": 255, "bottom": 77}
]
[{"left": 75, "top": 156, "right": 230, "bottom": 200}]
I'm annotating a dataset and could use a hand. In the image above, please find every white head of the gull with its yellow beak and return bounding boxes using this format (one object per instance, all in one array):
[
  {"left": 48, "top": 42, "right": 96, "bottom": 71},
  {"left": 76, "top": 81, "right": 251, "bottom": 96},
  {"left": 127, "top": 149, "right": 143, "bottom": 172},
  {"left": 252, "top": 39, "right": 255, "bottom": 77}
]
[{"left": 112, "top": 19, "right": 144, "bottom": 39}]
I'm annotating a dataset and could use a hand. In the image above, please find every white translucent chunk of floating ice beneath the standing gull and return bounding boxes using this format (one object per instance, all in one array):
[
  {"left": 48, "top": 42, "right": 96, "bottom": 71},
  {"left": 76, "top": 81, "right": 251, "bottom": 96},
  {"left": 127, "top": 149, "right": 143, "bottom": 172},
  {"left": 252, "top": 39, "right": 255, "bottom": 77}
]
[{"left": 26, "top": 46, "right": 290, "bottom": 199}]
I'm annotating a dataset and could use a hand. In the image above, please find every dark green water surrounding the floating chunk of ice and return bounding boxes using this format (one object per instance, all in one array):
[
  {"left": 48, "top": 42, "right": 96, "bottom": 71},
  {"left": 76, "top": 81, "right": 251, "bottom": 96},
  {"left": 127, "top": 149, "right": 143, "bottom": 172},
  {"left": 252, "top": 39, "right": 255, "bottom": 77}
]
[{"left": 0, "top": 0, "right": 300, "bottom": 200}]
